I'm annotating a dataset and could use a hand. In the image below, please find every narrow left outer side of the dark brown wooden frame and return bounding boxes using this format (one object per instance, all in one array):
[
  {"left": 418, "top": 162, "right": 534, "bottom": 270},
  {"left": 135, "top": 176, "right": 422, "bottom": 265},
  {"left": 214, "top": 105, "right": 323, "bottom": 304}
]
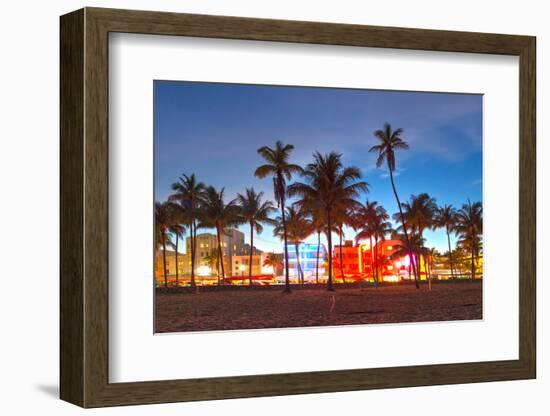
[{"left": 59, "top": 10, "right": 85, "bottom": 406}]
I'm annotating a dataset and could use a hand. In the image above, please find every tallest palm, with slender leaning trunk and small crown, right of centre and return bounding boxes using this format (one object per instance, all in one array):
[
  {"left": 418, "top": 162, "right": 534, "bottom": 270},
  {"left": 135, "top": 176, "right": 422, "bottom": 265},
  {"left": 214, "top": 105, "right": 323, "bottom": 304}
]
[{"left": 369, "top": 123, "right": 420, "bottom": 289}]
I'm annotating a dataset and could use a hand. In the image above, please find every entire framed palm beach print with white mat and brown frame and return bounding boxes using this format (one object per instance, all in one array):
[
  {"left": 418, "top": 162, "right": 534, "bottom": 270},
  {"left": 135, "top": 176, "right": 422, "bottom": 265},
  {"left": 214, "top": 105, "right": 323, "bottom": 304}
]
[{"left": 60, "top": 8, "right": 536, "bottom": 407}]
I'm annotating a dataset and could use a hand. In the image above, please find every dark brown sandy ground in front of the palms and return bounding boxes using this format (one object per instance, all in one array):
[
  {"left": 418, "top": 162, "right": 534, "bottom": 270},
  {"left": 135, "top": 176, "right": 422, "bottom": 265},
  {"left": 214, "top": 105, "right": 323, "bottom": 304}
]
[{"left": 155, "top": 282, "right": 482, "bottom": 332}]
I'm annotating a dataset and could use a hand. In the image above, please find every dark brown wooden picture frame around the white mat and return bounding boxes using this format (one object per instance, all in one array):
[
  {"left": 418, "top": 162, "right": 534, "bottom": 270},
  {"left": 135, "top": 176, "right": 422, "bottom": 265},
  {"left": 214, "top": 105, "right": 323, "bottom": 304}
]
[{"left": 60, "top": 8, "right": 536, "bottom": 407}]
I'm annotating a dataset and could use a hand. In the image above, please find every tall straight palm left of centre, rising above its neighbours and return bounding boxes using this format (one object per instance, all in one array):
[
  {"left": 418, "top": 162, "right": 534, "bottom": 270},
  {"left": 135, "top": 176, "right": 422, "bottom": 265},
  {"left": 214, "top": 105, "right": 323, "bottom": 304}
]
[{"left": 254, "top": 140, "right": 303, "bottom": 293}]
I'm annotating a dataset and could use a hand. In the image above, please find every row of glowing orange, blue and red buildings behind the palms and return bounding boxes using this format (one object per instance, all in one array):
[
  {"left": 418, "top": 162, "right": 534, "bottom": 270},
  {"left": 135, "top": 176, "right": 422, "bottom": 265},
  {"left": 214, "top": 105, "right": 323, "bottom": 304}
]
[{"left": 156, "top": 229, "right": 422, "bottom": 284}]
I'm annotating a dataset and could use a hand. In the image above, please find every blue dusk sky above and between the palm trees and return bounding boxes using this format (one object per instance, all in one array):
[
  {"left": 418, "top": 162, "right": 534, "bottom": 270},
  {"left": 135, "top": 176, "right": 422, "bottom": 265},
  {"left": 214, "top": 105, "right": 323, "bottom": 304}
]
[{"left": 154, "top": 81, "right": 482, "bottom": 251}]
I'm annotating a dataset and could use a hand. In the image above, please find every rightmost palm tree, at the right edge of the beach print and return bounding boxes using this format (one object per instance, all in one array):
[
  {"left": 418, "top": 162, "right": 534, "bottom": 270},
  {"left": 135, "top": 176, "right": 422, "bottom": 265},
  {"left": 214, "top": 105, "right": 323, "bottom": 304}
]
[{"left": 455, "top": 199, "right": 483, "bottom": 281}]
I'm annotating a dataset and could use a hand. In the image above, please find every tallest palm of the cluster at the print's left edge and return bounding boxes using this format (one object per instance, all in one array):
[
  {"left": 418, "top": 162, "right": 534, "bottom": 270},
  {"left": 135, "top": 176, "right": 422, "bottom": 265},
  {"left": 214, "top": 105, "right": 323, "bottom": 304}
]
[{"left": 168, "top": 173, "right": 205, "bottom": 289}]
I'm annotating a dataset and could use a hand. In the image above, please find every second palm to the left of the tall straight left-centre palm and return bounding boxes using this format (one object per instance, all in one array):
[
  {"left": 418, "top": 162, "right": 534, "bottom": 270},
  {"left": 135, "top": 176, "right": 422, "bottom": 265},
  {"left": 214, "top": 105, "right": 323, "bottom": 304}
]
[{"left": 198, "top": 186, "right": 240, "bottom": 285}]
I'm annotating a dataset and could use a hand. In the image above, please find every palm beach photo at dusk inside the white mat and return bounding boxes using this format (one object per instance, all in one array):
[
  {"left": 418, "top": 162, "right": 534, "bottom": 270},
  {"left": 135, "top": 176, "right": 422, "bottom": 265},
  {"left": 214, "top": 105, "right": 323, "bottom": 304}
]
[{"left": 154, "top": 80, "right": 483, "bottom": 333}]
